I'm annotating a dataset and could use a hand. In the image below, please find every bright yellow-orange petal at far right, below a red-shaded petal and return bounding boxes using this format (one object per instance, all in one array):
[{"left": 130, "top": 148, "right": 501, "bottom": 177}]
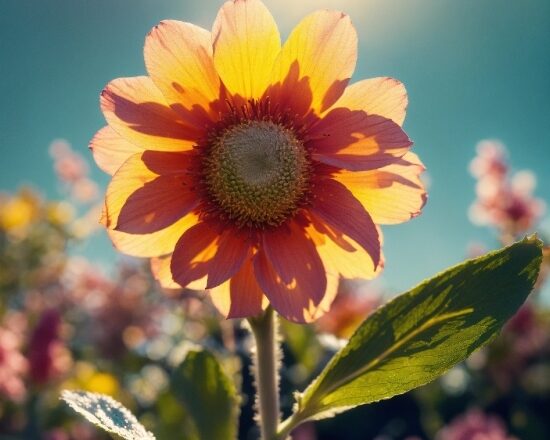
[{"left": 334, "top": 152, "right": 426, "bottom": 224}]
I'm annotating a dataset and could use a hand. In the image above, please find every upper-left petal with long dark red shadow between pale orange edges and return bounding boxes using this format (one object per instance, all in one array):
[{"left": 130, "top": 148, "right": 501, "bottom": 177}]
[{"left": 100, "top": 76, "right": 203, "bottom": 151}]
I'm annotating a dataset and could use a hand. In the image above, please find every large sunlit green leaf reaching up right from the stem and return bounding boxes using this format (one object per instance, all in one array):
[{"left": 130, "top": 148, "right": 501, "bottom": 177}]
[{"left": 281, "top": 238, "right": 542, "bottom": 437}]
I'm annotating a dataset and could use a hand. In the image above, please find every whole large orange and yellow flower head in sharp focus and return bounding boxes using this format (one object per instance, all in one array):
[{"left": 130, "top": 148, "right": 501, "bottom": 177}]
[{"left": 91, "top": 0, "right": 426, "bottom": 322}]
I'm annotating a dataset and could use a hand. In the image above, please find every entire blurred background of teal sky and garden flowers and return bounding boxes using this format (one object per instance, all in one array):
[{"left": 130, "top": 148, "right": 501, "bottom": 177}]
[{"left": 0, "top": 0, "right": 550, "bottom": 440}]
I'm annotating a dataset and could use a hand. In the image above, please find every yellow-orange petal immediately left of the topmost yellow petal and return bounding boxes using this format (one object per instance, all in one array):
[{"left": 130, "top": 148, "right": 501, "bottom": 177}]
[{"left": 144, "top": 20, "right": 221, "bottom": 124}]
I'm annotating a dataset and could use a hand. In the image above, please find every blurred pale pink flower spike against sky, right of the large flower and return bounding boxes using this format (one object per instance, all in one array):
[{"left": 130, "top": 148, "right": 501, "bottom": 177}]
[{"left": 470, "top": 140, "right": 545, "bottom": 237}]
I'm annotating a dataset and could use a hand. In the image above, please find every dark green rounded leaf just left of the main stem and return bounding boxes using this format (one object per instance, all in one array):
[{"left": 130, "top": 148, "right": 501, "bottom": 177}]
[{"left": 172, "top": 351, "right": 239, "bottom": 440}]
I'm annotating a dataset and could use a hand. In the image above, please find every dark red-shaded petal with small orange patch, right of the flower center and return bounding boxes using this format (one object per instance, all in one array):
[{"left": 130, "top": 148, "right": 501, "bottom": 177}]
[{"left": 309, "top": 108, "right": 412, "bottom": 171}]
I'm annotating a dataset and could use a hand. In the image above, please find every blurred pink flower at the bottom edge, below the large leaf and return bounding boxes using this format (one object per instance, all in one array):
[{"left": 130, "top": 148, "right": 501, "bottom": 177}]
[{"left": 435, "top": 409, "right": 515, "bottom": 440}]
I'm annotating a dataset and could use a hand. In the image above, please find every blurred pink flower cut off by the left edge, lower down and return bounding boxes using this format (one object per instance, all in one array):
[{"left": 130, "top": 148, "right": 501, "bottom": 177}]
[{"left": 0, "top": 317, "right": 28, "bottom": 403}]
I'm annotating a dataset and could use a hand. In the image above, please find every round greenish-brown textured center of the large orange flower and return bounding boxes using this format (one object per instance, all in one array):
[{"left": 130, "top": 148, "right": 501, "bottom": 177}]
[{"left": 204, "top": 121, "right": 310, "bottom": 227}]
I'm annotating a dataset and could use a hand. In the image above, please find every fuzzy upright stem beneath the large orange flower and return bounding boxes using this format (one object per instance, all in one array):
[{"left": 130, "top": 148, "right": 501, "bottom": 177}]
[{"left": 248, "top": 307, "right": 280, "bottom": 440}]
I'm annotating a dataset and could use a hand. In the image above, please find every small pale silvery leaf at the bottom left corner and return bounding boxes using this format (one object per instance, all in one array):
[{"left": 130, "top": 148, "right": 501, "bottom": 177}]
[{"left": 61, "top": 390, "right": 155, "bottom": 440}]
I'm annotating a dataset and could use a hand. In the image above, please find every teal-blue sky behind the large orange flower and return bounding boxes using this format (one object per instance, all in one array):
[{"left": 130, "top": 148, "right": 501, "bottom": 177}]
[{"left": 0, "top": 0, "right": 550, "bottom": 296}]
